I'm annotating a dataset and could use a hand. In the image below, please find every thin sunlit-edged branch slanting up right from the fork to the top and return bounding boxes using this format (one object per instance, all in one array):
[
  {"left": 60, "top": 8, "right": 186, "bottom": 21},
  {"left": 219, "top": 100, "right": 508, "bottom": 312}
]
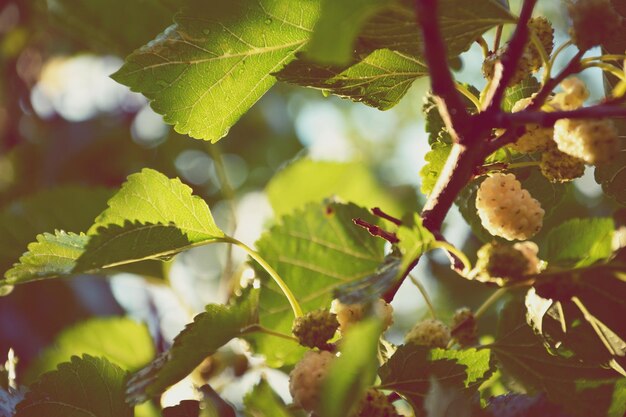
[{"left": 485, "top": 0, "right": 537, "bottom": 112}]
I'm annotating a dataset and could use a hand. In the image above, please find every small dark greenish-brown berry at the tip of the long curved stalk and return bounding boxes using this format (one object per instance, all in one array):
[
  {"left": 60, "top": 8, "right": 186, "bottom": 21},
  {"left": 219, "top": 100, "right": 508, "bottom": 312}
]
[{"left": 292, "top": 308, "right": 339, "bottom": 349}]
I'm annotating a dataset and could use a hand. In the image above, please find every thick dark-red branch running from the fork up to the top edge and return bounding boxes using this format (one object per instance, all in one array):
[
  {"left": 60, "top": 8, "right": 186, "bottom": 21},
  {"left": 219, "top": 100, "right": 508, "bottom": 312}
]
[{"left": 415, "top": 0, "right": 469, "bottom": 142}]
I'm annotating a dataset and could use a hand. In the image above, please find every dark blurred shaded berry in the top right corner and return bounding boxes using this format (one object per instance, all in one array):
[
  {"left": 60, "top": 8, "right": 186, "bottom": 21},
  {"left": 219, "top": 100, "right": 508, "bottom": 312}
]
[{"left": 567, "top": 0, "right": 623, "bottom": 51}]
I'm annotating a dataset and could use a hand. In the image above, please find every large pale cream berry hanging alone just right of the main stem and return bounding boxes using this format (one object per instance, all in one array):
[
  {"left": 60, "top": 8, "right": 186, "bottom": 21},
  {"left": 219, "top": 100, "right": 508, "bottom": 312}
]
[{"left": 476, "top": 173, "right": 544, "bottom": 240}]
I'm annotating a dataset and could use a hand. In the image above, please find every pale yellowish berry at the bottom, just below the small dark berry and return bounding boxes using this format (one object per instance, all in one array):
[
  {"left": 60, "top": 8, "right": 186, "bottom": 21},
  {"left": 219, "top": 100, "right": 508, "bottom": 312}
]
[{"left": 289, "top": 350, "right": 335, "bottom": 411}]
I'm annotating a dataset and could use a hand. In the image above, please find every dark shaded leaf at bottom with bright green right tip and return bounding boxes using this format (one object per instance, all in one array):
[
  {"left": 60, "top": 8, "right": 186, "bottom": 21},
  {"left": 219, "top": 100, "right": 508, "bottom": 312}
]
[{"left": 379, "top": 344, "right": 490, "bottom": 416}]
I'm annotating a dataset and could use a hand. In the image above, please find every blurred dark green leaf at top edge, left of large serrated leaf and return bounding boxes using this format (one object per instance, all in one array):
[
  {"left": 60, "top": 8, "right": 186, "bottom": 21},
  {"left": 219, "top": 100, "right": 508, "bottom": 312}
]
[{"left": 47, "top": 0, "right": 182, "bottom": 56}]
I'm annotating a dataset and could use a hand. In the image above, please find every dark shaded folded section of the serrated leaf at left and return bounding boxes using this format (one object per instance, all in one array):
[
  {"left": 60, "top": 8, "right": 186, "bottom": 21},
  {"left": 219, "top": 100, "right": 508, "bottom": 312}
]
[{"left": 73, "top": 221, "right": 193, "bottom": 272}]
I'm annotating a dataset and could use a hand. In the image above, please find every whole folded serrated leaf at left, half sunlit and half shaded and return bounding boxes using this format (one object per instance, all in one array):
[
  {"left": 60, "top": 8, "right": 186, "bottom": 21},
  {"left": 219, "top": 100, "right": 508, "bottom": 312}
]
[{"left": 4, "top": 169, "right": 224, "bottom": 284}]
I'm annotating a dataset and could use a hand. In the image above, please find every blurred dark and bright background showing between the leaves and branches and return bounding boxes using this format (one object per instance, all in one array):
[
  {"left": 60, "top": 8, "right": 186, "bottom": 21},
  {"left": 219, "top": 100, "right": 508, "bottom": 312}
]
[{"left": 0, "top": 0, "right": 614, "bottom": 410}]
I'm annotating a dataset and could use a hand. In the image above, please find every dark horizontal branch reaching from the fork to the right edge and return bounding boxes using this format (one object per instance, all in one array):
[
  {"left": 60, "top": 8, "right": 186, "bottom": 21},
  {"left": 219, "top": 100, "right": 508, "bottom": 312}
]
[{"left": 494, "top": 100, "right": 626, "bottom": 128}]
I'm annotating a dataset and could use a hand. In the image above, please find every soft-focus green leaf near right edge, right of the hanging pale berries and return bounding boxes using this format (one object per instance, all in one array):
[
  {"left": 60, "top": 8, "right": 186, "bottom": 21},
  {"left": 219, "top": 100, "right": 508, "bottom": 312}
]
[{"left": 541, "top": 217, "right": 615, "bottom": 267}]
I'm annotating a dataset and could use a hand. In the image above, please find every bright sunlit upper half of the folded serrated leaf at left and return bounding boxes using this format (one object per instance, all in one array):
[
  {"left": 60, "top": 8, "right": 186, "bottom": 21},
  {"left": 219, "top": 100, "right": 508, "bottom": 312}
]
[{"left": 88, "top": 168, "right": 224, "bottom": 242}]
